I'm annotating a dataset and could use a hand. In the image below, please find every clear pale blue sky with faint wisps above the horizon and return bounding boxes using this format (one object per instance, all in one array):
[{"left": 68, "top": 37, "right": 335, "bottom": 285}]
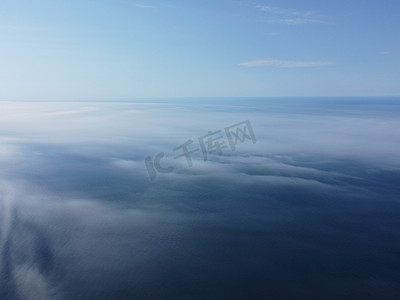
[{"left": 0, "top": 0, "right": 400, "bottom": 100}]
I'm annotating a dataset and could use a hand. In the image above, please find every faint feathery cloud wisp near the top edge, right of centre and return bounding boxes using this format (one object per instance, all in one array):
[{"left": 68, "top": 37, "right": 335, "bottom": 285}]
[{"left": 256, "top": 5, "right": 322, "bottom": 25}]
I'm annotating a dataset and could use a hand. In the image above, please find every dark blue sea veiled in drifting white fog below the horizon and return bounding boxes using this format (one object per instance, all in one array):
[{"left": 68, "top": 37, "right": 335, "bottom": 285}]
[{"left": 0, "top": 97, "right": 400, "bottom": 300}]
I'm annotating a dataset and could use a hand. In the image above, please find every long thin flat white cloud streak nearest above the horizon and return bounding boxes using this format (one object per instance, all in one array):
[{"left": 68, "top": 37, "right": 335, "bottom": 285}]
[{"left": 239, "top": 59, "right": 333, "bottom": 68}]
